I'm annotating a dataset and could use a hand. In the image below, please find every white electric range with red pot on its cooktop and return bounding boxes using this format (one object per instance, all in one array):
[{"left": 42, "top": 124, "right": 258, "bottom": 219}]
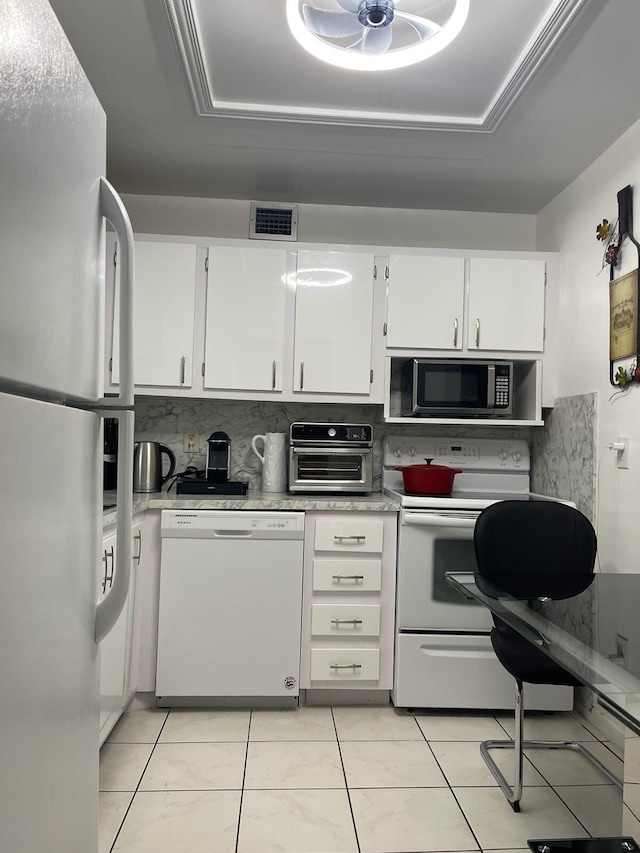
[{"left": 382, "top": 436, "right": 573, "bottom": 710}]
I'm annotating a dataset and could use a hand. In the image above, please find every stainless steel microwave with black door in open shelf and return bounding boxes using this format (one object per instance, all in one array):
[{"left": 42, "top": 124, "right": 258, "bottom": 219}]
[{"left": 400, "top": 358, "right": 513, "bottom": 418}]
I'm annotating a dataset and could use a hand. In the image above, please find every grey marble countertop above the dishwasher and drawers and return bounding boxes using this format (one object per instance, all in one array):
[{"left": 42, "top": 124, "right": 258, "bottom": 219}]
[{"left": 103, "top": 491, "right": 400, "bottom": 527}]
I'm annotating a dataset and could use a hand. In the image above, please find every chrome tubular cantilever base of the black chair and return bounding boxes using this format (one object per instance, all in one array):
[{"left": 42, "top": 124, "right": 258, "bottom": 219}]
[{"left": 480, "top": 681, "right": 622, "bottom": 812}]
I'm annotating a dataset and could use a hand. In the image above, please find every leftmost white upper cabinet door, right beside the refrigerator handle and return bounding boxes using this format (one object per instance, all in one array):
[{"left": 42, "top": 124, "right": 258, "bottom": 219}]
[{"left": 112, "top": 240, "right": 197, "bottom": 388}]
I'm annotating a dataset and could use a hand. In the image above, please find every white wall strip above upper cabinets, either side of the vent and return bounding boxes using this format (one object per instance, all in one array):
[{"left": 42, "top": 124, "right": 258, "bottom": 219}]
[{"left": 123, "top": 195, "right": 536, "bottom": 251}]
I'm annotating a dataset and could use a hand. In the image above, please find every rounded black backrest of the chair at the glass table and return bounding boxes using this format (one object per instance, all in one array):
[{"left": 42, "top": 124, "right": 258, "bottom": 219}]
[{"left": 473, "top": 500, "right": 597, "bottom": 599}]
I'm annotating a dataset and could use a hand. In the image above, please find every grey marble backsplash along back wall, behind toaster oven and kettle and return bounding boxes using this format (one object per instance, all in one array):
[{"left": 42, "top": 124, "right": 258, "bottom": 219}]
[{"left": 135, "top": 397, "right": 531, "bottom": 489}]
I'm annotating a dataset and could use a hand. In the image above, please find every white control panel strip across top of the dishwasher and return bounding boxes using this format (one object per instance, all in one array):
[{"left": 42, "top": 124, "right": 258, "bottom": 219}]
[{"left": 160, "top": 510, "right": 304, "bottom": 539}]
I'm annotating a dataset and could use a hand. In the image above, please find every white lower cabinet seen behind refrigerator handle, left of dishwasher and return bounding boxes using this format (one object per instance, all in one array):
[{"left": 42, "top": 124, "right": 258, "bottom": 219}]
[{"left": 99, "top": 522, "right": 142, "bottom": 746}]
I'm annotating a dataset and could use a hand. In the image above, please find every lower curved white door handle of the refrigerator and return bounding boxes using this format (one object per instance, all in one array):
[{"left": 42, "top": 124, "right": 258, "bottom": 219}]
[{"left": 96, "top": 410, "right": 134, "bottom": 643}]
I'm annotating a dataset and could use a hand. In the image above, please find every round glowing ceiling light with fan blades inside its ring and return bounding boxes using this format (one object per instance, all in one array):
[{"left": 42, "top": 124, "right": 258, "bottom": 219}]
[{"left": 287, "top": 0, "right": 470, "bottom": 71}]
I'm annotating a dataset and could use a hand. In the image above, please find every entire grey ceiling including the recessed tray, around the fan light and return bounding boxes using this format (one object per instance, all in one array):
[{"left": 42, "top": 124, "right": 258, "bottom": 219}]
[{"left": 50, "top": 0, "right": 640, "bottom": 213}]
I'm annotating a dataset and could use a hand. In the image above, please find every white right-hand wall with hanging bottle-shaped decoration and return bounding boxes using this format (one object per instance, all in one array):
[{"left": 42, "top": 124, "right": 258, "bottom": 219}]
[{"left": 537, "top": 119, "right": 640, "bottom": 572}]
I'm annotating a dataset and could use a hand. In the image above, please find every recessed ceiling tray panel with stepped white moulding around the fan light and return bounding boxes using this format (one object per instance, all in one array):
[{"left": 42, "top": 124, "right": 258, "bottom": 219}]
[{"left": 165, "top": 0, "right": 588, "bottom": 133}]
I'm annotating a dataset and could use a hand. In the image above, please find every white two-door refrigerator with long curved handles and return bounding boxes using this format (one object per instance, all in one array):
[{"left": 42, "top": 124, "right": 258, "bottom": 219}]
[{"left": 0, "top": 0, "right": 133, "bottom": 853}]
